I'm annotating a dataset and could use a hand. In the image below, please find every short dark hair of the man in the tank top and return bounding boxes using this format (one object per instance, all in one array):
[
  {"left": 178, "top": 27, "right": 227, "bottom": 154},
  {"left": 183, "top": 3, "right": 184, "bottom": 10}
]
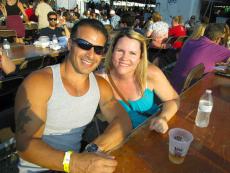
[{"left": 70, "top": 19, "right": 108, "bottom": 43}]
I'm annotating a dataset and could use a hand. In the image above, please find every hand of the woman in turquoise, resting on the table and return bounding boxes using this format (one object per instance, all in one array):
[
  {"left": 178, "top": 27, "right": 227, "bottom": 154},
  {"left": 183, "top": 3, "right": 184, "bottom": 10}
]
[{"left": 149, "top": 116, "right": 169, "bottom": 134}]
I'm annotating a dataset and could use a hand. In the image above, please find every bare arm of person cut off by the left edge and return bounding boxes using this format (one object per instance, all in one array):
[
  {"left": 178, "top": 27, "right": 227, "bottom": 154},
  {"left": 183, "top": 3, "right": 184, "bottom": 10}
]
[{"left": 0, "top": 49, "right": 16, "bottom": 79}]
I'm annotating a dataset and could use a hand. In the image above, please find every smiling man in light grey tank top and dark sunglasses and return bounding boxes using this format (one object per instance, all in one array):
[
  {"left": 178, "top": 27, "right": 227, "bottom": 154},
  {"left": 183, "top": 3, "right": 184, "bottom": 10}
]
[{"left": 15, "top": 19, "right": 131, "bottom": 173}]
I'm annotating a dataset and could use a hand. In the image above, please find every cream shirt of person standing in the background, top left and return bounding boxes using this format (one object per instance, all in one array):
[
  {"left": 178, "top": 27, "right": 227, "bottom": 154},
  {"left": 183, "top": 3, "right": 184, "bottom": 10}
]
[{"left": 35, "top": 0, "right": 53, "bottom": 29}]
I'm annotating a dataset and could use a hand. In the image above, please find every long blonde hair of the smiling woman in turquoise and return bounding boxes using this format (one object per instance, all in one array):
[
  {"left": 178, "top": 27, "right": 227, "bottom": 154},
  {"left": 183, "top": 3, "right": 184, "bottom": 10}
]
[{"left": 105, "top": 28, "right": 148, "bottom": 94}]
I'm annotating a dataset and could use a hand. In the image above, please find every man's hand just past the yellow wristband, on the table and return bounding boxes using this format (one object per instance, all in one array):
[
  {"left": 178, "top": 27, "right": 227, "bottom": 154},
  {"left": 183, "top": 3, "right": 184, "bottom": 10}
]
[{"left": 70, "top": 152, "right": 117, "bottom": 173}]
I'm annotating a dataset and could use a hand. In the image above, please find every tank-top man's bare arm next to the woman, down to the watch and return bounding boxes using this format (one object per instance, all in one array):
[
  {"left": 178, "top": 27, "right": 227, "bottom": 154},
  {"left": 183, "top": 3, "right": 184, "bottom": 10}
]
[{"left": 91, "top": 76, "right": 132, "bottom": 151}]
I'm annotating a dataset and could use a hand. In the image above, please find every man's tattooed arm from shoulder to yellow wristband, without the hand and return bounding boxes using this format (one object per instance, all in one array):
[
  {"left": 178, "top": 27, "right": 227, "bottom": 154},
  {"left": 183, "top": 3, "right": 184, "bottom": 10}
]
[{"left": 15, "top": 71, "right": 64, "bottom": 171}]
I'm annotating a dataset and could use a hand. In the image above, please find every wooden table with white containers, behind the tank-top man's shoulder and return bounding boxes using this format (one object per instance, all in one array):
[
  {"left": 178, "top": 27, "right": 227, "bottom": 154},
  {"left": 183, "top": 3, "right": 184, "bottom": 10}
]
[{"left": 2, "top": 44, "right": 67, "bottom": 65}]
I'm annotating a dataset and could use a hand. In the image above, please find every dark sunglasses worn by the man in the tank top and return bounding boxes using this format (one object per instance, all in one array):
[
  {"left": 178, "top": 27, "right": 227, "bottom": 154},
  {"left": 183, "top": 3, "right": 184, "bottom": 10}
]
[{"left": 72, "top": 38, "right": 105, "bottom": 55}]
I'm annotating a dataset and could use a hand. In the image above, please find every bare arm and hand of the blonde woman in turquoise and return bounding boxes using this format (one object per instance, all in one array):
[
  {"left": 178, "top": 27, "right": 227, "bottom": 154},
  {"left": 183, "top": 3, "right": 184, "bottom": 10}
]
[{"left": 148, "top": 65, "right": 179, "bottom": 133}]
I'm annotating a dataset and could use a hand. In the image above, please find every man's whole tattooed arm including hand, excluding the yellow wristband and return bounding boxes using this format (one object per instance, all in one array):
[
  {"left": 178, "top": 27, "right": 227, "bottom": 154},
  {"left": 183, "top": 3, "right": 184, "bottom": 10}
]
[{"left": 15, "top": 69, "right": 117, "bottom": 173}]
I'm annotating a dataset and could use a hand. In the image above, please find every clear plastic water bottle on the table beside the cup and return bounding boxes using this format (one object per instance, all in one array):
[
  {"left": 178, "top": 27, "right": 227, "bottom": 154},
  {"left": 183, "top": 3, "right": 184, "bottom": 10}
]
[{"left": 195, "top": 90, "right": 213, "bottom": 127}]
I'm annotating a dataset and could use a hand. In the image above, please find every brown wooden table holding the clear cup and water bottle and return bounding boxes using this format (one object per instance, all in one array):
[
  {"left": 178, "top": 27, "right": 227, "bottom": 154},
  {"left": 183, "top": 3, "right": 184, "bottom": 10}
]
[{"left": 111, "top": 73, "right": 230, "bottom": 173}]
